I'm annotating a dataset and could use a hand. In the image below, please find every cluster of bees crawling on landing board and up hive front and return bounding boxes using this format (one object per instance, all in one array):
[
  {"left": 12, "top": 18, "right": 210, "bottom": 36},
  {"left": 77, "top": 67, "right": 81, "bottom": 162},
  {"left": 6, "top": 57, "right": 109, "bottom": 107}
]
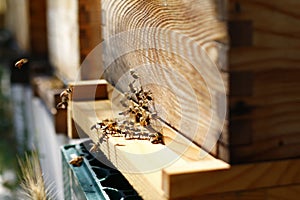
[{"left": 90, "top": 71, "right": 164, "bottom": 152}]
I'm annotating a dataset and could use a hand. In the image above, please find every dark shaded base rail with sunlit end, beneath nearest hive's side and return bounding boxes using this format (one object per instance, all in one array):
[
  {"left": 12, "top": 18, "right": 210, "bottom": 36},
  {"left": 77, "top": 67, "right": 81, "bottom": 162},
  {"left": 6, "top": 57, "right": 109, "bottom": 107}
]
[{"left": 163, "top": 159, "right": 300, "bottom": 199}]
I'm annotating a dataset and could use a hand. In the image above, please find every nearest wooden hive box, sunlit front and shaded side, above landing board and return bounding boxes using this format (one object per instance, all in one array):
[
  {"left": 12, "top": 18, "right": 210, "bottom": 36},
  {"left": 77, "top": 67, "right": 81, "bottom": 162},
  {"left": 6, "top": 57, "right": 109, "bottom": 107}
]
[{"left": 98, "top": 0, "right": 300, "bottom": 164}]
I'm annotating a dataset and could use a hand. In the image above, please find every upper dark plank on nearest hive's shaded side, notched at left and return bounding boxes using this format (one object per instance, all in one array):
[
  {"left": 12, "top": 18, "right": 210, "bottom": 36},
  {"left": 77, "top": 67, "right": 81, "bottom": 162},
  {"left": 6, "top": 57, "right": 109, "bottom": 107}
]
[{"left": 228, "top": 0, "right": 300, "bottom": 70}]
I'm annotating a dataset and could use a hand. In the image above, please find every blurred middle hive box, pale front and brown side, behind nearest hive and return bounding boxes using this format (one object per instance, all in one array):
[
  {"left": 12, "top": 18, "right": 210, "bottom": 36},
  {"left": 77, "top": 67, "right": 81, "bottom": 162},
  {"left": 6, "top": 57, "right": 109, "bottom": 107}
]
[{"left": 47, "top": 0, "right": 102, "bottom": 83}]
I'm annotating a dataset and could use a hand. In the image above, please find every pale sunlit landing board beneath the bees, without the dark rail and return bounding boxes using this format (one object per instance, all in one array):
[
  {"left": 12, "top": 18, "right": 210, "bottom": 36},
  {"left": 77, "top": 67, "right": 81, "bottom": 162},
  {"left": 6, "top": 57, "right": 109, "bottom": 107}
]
[{"left": 71, "top": 100, "right": 228, "bottom": 199}]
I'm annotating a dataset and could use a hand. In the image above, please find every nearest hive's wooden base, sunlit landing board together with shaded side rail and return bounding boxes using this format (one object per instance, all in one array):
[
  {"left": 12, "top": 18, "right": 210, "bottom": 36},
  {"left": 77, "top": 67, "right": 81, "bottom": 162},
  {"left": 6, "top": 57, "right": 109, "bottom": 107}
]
[{"left": 71, "top": 95, "right": 300, "bottom": 199}]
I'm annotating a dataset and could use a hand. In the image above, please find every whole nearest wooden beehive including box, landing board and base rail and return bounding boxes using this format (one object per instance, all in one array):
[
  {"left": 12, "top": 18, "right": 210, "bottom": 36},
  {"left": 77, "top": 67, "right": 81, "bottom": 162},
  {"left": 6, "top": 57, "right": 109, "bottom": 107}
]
[{"left": 70, "top": 0, "right": 300, "bottom": 199}]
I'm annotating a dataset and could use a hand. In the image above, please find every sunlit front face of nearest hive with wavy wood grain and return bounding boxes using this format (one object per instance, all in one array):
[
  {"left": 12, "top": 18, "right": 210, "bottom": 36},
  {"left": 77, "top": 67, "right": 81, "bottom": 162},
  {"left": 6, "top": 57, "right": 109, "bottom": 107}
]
[{"left": 102, "top": 0, "right": 228, "bottom": 161}]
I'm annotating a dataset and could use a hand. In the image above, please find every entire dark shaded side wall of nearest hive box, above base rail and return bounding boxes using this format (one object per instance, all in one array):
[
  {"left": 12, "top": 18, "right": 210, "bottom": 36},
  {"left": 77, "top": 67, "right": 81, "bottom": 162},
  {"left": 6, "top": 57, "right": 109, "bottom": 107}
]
[{"left": 227, "top": 0, "right": 300, "bottom": 163}]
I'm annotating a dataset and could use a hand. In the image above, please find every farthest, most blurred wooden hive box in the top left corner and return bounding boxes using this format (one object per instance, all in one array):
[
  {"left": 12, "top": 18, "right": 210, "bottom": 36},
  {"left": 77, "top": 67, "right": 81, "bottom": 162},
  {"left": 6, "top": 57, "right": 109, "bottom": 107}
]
[{"left": 5, "top": 0, "right": 48, "bottom": 58}]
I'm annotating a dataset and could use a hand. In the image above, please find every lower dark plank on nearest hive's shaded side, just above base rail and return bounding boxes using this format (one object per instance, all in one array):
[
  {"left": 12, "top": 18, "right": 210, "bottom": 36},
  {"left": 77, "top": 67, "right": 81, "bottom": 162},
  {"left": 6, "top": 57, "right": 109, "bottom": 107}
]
[{"left": 228, "top": 68, "right": 300, "bottom": 163}]
